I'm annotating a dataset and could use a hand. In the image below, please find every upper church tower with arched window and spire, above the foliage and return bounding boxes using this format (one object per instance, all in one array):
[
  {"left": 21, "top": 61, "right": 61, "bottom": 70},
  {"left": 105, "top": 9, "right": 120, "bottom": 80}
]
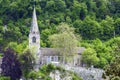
[{"left": 29, "top": 7, "right": 40, "bottom": 53}]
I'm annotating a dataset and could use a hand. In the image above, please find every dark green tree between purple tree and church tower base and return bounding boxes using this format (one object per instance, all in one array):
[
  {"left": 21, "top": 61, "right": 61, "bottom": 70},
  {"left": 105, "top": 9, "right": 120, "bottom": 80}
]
[{"left": 19, "top": 50, "right": 35, "bottom": 78}]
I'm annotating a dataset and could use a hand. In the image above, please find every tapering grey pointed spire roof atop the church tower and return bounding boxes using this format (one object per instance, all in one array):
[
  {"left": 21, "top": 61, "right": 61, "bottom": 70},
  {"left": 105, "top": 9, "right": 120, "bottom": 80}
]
[{"left": 30, "top": 7, "right": 39, "bottom": 32}]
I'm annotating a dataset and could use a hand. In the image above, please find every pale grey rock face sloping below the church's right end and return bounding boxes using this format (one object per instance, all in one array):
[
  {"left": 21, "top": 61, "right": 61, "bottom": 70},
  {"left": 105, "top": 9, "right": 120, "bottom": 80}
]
[{"left": 65, "top": 66, "right": 104, "bottom": 80}]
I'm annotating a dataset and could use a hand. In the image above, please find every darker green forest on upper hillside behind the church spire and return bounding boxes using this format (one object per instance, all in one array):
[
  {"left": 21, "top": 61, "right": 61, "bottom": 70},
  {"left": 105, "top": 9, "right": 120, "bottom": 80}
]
[{"left": 0, "top": 0, "right": 120, "bottom": 50}]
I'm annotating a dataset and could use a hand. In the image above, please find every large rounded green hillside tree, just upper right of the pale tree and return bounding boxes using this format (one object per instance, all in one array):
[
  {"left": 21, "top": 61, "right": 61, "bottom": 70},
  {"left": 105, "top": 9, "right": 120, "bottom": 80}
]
[{"left": 78, "top": 17, "right": 102, "bottom": 40}]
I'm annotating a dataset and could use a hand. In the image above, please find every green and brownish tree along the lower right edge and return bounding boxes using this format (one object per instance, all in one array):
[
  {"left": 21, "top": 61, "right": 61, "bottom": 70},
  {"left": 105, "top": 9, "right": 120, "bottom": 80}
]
[{"left": 105, "top": 37, "right": 120, "bottom": 80}]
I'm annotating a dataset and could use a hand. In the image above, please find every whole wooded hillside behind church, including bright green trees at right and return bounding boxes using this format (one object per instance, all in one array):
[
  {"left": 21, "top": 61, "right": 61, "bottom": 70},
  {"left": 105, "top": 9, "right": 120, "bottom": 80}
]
[{"left": 0, "top": 0, "right": 120, "bottom": 68}]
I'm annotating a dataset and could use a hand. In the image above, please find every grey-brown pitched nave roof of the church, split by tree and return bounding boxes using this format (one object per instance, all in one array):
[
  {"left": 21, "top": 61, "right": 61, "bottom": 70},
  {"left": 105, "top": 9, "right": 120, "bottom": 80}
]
[{"left": 41, "top": 47, "right": 85, "bottom": 56}]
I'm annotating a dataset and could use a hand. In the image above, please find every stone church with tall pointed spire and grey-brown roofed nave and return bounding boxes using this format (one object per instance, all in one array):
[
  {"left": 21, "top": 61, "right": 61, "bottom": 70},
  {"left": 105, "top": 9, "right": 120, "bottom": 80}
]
[{"left": 29, "top": 8, "right": 85, "bottom": 66}]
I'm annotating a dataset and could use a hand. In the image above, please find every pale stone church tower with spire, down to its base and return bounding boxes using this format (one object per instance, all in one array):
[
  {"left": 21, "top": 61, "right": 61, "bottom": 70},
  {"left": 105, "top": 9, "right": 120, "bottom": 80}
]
[{"left": 29, "top": 7, "right": 41, "bottom": 70}]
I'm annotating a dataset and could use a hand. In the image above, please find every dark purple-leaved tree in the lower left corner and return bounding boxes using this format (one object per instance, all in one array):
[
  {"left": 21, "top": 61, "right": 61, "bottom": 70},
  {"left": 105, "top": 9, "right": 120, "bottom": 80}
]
[{"left": 1, "top": 49, "right": 22, "bottom": 80}]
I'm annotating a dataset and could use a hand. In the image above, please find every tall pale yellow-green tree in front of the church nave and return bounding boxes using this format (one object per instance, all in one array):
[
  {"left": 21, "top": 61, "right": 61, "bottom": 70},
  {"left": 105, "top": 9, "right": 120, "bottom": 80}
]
[{"left": 49, "top": 23, "right": 78, "bottom": 61}]
